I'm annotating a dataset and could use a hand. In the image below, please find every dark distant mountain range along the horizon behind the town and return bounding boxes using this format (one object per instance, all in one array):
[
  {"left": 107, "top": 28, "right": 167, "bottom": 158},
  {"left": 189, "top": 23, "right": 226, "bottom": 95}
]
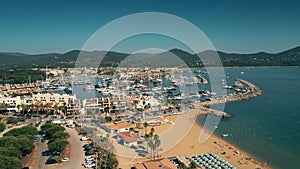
[{"left": 0, "top": 46, "right": 300, "bottom": 68}]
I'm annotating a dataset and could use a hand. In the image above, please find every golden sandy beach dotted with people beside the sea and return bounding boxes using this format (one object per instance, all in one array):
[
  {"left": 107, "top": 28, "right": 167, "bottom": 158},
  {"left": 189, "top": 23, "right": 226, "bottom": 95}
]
[{"left": 117, "top": 112, "right": 270, "bottom": 169}]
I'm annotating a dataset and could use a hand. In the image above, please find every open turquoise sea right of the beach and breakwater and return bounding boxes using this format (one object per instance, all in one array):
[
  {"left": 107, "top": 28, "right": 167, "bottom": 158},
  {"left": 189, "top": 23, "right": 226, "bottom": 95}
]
[{"left": 198, "top": 67, "right": 300, "bottom": 169}]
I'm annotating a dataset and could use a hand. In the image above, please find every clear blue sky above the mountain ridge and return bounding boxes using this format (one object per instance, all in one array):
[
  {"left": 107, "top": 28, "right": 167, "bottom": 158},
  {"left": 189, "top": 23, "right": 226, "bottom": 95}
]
[{"left": 0, "top": 0, "right": 300, "bottom": 54}]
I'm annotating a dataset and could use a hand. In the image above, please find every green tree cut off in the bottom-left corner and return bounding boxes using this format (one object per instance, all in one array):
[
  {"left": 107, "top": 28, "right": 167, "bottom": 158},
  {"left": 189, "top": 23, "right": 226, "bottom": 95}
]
[{"left": 0, "top": 154, "right": 22, "bottom": 169}]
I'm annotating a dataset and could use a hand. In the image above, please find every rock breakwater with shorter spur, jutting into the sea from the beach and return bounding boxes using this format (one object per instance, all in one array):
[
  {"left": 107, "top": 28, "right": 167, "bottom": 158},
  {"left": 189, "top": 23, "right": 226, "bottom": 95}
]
[{"left": 199, "top": 79, "right": 262, "bottom": 117}]
